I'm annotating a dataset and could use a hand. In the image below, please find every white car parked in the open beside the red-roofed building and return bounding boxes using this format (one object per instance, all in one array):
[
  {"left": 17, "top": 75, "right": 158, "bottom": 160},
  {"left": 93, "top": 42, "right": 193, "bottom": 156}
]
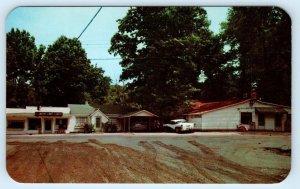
[{"left": 163, "top": 119, "right": 195, "bottom": 133}]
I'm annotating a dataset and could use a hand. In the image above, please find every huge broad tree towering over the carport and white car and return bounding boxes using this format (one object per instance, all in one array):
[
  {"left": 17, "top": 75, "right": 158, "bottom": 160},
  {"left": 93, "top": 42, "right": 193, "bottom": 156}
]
[{"left": 109, "top": 7, "right": 217, "bottom": 118}]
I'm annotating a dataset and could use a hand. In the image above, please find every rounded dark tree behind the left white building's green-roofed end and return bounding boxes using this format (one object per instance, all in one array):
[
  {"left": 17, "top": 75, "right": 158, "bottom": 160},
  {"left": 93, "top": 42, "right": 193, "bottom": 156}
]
[{"left": 41, "top": 36, "right": 110, "bottom": 106}]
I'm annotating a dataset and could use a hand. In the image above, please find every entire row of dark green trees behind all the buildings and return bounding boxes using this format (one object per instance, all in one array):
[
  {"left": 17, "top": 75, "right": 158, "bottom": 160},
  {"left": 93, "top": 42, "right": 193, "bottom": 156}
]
[{"left": 7, "top": 7, "right": 291, "bottom": 119}]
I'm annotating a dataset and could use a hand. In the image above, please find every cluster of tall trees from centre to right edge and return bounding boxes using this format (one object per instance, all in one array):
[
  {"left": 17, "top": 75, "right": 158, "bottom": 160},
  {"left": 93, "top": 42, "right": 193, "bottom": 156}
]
[{"left": 109, "top": 7, "right": 291, "bottom": 118}]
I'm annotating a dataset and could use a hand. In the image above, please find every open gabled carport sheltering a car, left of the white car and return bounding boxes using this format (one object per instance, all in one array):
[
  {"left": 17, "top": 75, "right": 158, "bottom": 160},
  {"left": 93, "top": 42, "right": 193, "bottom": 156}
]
[{"left": 121, "top": 110, "right": 159, "bottom": 132}]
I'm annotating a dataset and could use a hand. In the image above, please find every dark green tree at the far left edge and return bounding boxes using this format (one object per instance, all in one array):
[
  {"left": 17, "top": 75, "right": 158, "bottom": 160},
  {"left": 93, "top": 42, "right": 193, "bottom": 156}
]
[{"left": 6, "top": 28, "right": 37, "bottom": 107}]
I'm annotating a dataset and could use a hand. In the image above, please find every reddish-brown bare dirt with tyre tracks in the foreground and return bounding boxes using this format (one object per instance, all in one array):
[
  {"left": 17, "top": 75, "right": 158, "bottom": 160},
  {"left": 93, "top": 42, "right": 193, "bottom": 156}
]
[{"left": 7, "top": 139, "right": 288, "bottom": 183}]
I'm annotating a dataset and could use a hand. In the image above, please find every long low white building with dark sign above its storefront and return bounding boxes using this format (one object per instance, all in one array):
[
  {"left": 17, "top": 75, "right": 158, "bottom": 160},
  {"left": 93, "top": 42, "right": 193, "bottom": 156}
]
[{"left": 6, "top": 103, "right": 109, "bottom": 134}]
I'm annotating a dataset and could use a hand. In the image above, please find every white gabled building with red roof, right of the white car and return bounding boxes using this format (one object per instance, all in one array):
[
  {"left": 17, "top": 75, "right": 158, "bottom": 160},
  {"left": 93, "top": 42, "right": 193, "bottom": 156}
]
[{"left": 185, "top": 99, "right": 291, "bottom": 131}]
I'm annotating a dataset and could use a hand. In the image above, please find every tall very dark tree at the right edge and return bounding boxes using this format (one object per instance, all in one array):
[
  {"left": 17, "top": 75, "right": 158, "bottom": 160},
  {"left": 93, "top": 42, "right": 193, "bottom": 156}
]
[{"left": 222, "top": 7, "right": 291, "bottom": 105}]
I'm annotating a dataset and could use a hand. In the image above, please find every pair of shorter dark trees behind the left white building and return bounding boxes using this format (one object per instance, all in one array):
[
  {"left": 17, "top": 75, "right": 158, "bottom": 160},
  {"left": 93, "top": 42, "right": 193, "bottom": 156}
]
[{"left": 7, "top": 29, "right": 110, "bottom": 107}]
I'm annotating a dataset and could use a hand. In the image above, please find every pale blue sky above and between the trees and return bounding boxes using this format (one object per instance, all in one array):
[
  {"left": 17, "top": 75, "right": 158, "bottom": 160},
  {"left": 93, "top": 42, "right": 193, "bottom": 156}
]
[{"left": 5, "top": 7, "right": 228, "bottom": 83}]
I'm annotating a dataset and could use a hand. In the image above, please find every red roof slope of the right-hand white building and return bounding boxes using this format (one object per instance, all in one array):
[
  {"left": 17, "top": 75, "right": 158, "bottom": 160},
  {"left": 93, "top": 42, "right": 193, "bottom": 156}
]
[{"left": 189, "top": 99, "right": 247, "bottom": 114}]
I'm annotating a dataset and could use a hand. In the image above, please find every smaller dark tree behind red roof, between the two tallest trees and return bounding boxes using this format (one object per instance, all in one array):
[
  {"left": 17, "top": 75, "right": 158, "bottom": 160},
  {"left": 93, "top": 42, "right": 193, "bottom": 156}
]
[{"left": 195, "top": 35, "right": 238, "bottom": 101}]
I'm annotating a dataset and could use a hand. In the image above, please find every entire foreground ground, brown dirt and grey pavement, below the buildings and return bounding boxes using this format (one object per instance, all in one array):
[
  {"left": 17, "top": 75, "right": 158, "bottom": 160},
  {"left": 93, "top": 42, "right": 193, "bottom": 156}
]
[{"left": 6, "top": 132, "right": 291, "bottom": 183}]
